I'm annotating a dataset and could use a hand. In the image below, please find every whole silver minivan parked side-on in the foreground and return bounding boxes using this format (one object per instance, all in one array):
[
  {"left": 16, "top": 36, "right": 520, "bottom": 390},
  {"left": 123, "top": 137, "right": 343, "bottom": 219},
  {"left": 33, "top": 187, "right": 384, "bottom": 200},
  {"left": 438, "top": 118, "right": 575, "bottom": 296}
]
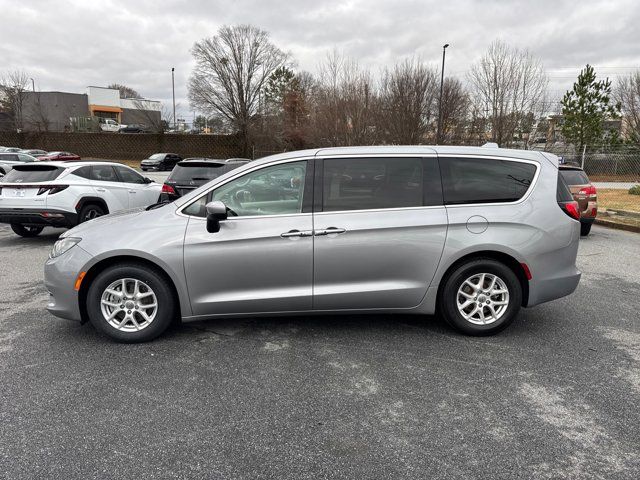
[{"left": 45, "top": 146, "right": 580, "bottom": 342}]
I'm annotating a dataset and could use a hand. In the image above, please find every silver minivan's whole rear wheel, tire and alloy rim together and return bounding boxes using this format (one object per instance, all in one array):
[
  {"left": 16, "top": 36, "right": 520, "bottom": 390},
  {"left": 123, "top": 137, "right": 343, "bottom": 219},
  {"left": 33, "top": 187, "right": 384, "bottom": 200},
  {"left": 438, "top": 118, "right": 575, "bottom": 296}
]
[{"left": 439, "top": 258, "right": 522, "bottom": 335}]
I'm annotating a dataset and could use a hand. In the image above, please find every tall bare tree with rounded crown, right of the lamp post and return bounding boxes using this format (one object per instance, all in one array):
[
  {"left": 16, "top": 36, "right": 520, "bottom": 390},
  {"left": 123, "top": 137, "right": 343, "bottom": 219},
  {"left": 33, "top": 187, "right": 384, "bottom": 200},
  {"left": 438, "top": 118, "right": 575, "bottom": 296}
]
[{"left": 469, "top": 40, "right": 548, "bottom": 145}]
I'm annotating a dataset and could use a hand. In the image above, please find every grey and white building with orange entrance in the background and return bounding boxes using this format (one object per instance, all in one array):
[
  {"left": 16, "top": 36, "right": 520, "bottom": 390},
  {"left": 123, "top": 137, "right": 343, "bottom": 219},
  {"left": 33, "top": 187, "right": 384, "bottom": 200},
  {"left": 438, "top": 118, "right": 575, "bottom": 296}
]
[{"left": 22, "top": 86, "right": 162, "bottom": 132}]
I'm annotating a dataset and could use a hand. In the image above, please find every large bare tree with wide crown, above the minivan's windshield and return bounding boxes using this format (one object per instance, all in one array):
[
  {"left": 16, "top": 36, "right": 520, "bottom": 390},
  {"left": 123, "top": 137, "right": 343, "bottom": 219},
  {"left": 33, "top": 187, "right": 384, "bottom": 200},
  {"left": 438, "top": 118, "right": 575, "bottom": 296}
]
[{"left": 189, "top": 25, "right": 288, "bottom": 154}]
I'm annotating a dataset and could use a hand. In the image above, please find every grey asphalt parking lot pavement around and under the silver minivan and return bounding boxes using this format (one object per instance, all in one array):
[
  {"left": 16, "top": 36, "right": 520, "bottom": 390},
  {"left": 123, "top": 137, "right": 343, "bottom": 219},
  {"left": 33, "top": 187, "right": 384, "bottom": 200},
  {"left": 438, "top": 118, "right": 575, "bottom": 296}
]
[{"left": 0, "top": 226, "right": 640, "bottom": 479}]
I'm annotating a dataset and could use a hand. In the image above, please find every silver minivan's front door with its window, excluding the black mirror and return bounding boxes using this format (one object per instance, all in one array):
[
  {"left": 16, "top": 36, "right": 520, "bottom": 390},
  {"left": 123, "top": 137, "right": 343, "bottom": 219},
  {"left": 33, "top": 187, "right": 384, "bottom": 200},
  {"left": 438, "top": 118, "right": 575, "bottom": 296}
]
[{"left": 183, "top": 160, "right": 313, "bottom": 316}]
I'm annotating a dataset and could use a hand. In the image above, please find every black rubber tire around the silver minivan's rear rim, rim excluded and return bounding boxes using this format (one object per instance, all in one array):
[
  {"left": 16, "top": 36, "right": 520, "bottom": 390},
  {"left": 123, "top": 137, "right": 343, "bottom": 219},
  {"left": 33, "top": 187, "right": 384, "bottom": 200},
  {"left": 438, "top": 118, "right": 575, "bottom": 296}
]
[{"left": 438, "top": 258, "right": 522, "bottom": 336}]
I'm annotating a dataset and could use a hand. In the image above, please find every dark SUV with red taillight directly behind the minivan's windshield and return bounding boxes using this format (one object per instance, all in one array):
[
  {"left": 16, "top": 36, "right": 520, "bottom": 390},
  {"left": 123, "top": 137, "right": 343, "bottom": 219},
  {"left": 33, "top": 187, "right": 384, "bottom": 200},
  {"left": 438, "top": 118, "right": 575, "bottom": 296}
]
[{"left": 159, "top": 158, "right": 249, "bottom": 202}]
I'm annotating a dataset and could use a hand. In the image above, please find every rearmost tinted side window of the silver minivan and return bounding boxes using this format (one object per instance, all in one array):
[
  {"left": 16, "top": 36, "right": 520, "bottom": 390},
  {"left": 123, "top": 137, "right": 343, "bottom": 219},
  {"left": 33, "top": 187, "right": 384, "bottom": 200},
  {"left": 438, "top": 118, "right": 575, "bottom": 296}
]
[{"left": 440, "top": 158, "right": 536, "bottom": 205}]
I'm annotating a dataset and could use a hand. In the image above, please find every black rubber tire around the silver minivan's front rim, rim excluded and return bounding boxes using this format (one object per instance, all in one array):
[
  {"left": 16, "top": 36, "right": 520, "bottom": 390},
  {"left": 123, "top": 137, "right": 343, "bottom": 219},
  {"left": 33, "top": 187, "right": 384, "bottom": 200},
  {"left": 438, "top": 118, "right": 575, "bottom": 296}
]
[{"left": 86, "top": 264, "right": 176, "bottom": 343}]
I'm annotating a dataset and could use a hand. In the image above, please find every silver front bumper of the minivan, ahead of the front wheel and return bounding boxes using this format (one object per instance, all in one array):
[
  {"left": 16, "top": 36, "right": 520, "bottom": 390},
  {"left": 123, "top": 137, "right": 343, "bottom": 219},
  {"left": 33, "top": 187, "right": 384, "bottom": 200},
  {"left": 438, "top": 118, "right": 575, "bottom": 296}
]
[{"left": 44, "top": 245, "right": 92, "bottom": 322}]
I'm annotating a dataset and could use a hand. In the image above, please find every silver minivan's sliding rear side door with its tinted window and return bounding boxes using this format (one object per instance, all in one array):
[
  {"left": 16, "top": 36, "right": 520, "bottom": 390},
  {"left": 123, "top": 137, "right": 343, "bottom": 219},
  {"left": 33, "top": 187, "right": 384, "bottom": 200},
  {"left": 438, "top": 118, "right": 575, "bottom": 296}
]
[{"left": 313, "top": 155, "right": 447, "bottom": 310}]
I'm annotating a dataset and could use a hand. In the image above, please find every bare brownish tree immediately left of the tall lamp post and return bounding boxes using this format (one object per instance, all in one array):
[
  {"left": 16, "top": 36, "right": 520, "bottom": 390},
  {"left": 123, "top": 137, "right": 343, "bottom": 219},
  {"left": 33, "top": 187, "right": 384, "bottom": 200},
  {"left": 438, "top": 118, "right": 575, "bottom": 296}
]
[{"left": 379, "top": 59, "right": 438, "bottom": 145}]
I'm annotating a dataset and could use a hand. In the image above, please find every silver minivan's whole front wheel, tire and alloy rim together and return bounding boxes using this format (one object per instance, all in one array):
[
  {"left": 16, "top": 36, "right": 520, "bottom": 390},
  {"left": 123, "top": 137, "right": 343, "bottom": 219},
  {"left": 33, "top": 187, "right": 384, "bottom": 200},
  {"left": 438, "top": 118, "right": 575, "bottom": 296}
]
[{"left": 87, "top": 264, "right": 175, "bottom": 343}]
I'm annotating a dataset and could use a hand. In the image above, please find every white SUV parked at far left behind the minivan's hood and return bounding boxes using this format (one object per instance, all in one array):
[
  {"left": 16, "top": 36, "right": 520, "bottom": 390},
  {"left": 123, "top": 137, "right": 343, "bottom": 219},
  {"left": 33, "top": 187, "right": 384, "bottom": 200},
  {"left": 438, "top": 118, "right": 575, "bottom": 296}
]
[{"left": 0, "top": 162, "right": 162, "bottom": 237}]
